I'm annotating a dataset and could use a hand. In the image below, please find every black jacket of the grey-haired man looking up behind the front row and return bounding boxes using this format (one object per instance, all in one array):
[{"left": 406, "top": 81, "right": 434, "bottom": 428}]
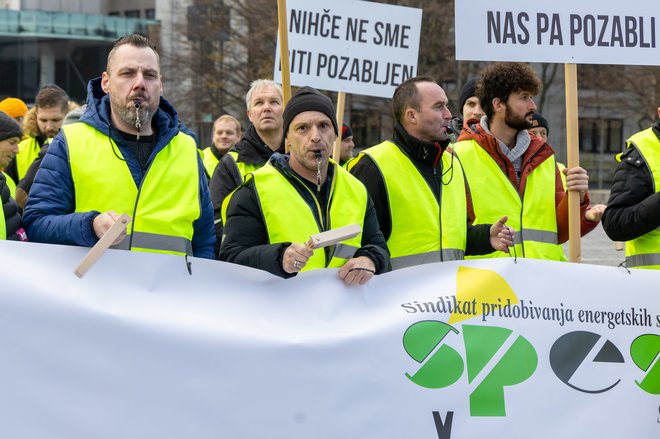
[{"left": 209, "top": 124, "right": 284, "bottom": 253}]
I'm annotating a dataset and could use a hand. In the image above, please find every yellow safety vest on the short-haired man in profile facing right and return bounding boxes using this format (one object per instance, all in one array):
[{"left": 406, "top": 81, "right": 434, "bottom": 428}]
[{"left": 349, "top": 141, "right": 467, "bottom": 269}]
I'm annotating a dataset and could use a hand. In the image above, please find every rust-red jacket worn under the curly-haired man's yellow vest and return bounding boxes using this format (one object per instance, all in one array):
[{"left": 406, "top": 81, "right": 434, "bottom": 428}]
[{"left": 457, "top": 124, "right": 598, "bottom": 244}]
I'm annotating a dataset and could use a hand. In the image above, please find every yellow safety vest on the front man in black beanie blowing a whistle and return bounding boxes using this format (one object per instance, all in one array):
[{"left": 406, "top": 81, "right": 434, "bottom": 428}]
[{"left": 249, "top": 161, "right": 367, "bottom": 271}]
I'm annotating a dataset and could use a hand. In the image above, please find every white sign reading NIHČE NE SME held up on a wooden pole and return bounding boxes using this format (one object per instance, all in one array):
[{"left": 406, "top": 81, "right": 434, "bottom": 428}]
[{"left": 273, "top": 0, "right": 422, "bottom": 98}]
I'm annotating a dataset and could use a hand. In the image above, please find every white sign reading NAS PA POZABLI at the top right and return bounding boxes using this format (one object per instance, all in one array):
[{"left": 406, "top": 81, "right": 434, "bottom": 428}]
[{"left": 455, "top": 0, "right": 660, "bottom": 65}]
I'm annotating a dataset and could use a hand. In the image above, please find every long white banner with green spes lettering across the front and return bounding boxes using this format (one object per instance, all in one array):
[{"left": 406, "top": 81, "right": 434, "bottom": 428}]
[{"left": 0, "top": 241, "right": 660, "bottom": 439}]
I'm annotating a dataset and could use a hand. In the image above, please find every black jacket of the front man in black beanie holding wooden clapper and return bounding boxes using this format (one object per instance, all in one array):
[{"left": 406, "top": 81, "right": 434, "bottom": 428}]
[{"left": 220, "top": 154, "right": 390, "bottom": 278}]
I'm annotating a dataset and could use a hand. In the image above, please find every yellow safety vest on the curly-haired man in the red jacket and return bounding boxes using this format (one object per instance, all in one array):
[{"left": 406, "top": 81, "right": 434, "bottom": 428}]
[{"left": 454, "top": 140, "right": 566, "bottom": 261}]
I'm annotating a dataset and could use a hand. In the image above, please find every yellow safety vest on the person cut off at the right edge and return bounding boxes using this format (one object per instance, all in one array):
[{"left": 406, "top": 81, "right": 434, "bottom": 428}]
[{"left": 626, "top": 128, "right": 660, "bottom": 269}]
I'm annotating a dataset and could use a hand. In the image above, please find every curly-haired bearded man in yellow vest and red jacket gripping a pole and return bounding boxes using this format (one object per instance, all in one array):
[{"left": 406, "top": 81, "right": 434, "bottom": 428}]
[{"left": 453, "top": 63, "right": 595, "bottom": 260}]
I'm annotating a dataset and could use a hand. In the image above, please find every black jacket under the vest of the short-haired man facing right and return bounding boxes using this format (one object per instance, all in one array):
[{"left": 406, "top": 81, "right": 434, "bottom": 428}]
[{"left": 351, "top": 122, "right": 494, "bottom": 255}]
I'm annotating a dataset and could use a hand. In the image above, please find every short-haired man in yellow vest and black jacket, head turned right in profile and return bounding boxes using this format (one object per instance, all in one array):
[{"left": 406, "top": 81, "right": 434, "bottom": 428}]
[{"left": 347, "top": 76, "right": 511, "bottom": 269}]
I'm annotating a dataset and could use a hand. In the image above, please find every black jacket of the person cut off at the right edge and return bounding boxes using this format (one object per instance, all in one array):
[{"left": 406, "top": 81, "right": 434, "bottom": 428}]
[{"left": 603, "top": 122, "right": 660, "bottom": 241}]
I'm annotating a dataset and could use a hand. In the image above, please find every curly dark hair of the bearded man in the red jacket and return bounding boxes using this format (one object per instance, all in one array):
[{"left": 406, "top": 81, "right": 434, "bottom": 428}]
[{"left": 476, "top": 62, "right": 541, "bottom": 119}]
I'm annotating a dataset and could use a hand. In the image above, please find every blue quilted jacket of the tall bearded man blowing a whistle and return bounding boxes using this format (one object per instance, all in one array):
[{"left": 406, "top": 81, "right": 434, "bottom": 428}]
[{"left": 23, "top": 78, "right": 215, "bottom": 259}]
